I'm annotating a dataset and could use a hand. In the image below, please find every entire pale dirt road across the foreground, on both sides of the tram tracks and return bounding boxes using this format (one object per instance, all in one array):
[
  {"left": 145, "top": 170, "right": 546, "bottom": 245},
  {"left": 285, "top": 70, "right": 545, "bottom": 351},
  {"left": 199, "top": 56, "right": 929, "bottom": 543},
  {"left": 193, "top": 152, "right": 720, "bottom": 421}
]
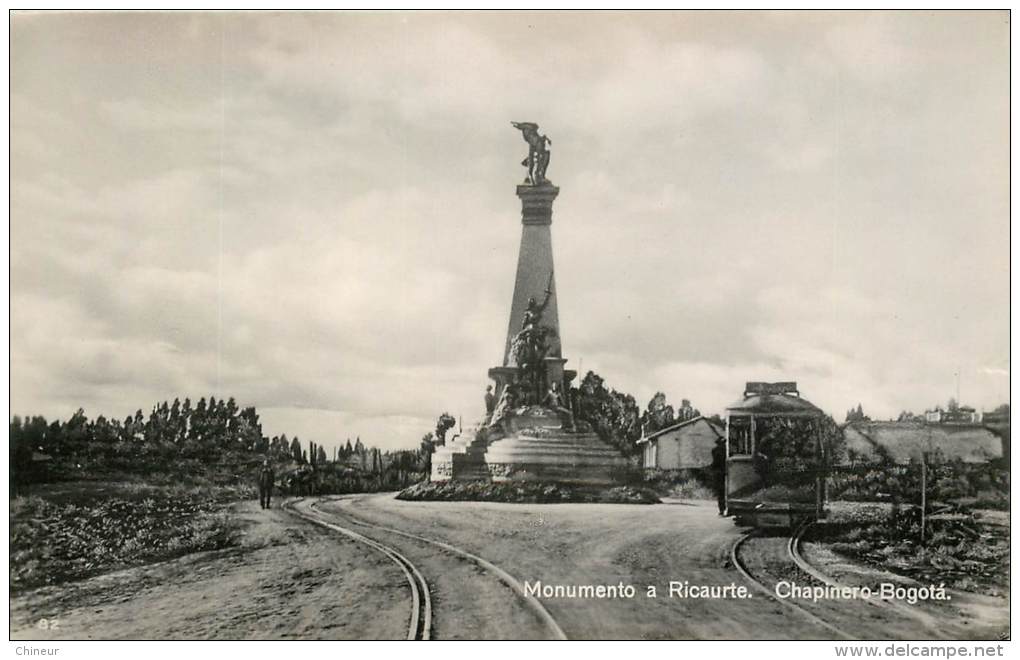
[{"left": 11, "top": 494, "right": 1009, "bottom": 640}]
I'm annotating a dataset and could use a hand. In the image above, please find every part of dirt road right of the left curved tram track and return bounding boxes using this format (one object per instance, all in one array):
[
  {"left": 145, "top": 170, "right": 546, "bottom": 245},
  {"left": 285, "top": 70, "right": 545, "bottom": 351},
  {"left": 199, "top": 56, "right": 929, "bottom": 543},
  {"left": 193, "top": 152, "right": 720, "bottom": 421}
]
[{"left": 319, "top": 495, "right": 1009, "bottom": 640}]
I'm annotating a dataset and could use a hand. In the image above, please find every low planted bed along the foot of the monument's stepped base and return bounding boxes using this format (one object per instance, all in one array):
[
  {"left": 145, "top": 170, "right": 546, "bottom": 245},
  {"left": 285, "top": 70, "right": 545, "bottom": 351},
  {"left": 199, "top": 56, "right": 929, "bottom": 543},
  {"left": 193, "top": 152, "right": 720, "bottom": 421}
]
[{"left": 397, "top": 481, "right": 659, "bottom": 504}]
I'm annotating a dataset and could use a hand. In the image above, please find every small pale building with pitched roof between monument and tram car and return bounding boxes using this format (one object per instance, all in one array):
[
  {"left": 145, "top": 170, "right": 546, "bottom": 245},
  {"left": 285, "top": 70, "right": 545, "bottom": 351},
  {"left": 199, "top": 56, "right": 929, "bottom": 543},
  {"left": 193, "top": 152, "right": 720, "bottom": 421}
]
[{"left": 638, "top": 415, "right": 726, "bottom": 470}]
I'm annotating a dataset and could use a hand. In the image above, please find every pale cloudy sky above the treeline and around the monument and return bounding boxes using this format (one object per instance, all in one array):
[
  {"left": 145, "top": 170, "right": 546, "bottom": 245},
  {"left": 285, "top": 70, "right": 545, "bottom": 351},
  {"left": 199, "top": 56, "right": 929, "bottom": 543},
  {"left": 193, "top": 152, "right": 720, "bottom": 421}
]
[{"left": 10, "top": 11, "right": 1010, "bottom": 448}]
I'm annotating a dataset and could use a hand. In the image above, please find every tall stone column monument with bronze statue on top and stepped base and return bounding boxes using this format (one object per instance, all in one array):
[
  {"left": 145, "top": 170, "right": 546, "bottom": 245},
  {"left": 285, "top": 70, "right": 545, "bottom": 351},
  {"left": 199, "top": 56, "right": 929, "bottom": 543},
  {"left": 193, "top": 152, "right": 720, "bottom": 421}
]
[{"left": 431, "top": 121, "right": 628, "bottom": 485}]
